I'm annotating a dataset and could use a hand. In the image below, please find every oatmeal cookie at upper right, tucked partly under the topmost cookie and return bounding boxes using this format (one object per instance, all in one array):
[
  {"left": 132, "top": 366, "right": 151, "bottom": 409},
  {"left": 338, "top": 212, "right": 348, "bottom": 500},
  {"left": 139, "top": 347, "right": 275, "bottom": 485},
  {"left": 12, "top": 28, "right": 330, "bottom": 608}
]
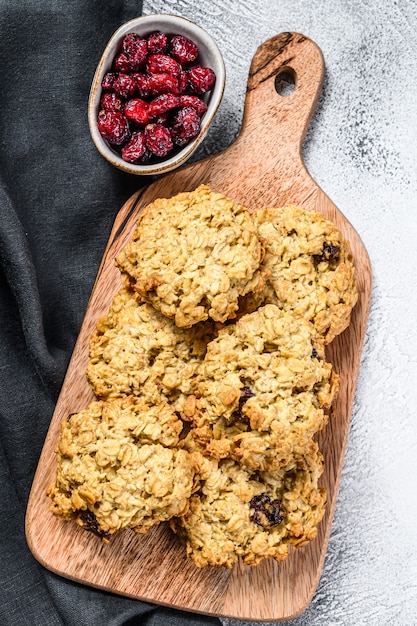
[{"left": 249, "top": 205, "right": 358, "bottom": 343}]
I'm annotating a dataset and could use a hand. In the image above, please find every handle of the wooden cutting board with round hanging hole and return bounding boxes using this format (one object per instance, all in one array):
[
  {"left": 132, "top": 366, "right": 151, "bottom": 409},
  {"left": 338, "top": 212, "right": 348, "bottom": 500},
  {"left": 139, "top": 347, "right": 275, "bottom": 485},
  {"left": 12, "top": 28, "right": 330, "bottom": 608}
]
[{"left": 235, "top": 32, "right": 324, "bottom": 162}]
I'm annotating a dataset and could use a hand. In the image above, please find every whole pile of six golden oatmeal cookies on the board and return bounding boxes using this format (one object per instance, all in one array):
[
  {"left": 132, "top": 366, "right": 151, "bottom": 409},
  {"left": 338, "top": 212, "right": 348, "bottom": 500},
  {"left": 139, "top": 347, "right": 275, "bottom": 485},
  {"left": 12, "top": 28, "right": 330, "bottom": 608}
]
[{"left": 48, "top": 185, "right": 357, "bottom": 567}]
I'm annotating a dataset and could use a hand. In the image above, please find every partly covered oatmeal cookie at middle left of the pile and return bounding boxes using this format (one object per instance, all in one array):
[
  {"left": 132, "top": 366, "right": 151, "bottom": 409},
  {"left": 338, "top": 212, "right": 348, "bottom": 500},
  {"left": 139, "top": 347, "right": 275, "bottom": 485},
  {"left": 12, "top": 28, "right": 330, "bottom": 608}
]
[{"left": 87, "top": 289, "right": 214, "bottom": 411}]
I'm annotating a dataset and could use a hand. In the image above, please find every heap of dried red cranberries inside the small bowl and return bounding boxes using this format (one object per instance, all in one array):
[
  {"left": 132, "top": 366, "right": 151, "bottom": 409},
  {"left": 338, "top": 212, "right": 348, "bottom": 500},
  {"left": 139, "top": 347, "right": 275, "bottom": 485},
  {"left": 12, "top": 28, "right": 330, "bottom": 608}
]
[{"left": 97, "top": 31, "right": 216, "bottom": 165}]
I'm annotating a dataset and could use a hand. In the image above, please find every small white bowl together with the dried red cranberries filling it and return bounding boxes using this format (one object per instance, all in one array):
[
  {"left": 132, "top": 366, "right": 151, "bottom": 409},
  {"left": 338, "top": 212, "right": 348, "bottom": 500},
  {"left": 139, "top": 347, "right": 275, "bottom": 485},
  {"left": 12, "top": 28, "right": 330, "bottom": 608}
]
[{"left": 88, "top": 14, "right": 225, "bottom": 175}]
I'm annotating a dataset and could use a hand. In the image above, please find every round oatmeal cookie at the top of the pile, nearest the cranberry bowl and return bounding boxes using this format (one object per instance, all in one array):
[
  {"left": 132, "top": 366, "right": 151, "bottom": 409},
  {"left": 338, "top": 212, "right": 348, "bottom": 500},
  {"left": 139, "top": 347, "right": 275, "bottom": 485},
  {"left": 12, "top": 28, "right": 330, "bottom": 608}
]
[{"left": 116, "top": 185, "right": 266, "bottom": 327}]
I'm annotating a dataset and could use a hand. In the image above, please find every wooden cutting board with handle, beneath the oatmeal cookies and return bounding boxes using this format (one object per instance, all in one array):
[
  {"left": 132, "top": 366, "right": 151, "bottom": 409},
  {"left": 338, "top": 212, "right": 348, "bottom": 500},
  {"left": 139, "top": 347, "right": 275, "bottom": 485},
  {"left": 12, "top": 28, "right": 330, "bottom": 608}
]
[{"left": 26, "top": 33, "right": 372, "bottom": 621}]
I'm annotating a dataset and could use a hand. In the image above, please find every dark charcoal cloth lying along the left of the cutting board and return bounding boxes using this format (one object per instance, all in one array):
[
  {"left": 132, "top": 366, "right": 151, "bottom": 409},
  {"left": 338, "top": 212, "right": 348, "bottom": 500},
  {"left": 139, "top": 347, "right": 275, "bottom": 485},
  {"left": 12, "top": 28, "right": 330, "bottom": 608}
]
[{"left": 0, "top": 0, "right": 218, "bottom": 626}]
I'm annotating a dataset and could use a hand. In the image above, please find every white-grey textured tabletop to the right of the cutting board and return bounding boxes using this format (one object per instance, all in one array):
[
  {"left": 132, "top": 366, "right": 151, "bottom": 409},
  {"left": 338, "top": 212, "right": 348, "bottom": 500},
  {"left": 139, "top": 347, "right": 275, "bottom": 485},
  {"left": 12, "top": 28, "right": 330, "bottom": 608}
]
[{"left": 144, "top": 0, "right": 417, "bottom": 626}]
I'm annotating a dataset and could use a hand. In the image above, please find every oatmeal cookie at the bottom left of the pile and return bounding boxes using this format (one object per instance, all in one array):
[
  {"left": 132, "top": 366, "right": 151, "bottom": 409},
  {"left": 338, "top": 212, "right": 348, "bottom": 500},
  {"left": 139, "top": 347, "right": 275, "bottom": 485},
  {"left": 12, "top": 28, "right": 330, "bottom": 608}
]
[{"left": 48, "top": 397, "right": 199, "bottom": 540}]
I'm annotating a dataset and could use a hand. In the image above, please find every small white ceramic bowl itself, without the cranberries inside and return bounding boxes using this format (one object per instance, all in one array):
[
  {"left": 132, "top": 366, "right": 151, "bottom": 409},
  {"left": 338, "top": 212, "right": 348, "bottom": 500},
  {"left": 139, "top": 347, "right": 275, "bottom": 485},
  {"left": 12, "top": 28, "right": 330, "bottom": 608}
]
[{"left": 88, "top": 14, "right": 226, "bottom": 176}]
